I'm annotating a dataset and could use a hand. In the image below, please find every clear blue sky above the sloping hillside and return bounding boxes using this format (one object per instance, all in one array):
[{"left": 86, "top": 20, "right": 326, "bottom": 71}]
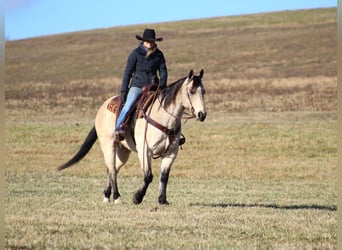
[{"left": 4, "top": 0, "right": 337, "bottom": 40}]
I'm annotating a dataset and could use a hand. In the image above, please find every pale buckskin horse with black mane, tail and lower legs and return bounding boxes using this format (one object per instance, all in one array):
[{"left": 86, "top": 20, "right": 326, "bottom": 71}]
[{"left": 57, "top": 69, "right": 207, "bottom": 205}]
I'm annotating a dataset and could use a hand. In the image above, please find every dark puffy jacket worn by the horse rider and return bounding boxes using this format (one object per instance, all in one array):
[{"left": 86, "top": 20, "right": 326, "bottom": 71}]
[{"left": 121, "top": 43, "right": 167, "bottom": 94}]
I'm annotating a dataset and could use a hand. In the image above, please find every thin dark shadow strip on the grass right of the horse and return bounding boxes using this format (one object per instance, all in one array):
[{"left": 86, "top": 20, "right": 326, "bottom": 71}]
[{"left": 189, "top": 203, "right": 337, "bottom": 211}]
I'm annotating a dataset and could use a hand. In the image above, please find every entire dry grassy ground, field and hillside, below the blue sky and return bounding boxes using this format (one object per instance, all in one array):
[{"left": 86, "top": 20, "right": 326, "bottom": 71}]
[{"left": 5, "top": 9, "right": 337, "bottom": 249}]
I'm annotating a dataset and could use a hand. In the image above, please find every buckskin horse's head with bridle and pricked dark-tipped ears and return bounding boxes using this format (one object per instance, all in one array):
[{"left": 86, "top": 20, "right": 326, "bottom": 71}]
[{"left": 183, "top": 69, "right": 207, "bottom": 122}]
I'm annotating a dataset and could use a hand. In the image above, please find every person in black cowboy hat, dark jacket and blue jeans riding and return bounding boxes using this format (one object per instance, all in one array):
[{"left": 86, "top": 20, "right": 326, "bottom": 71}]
[{"left": 114, "top": 29, "right": 167, "bottom": 140}]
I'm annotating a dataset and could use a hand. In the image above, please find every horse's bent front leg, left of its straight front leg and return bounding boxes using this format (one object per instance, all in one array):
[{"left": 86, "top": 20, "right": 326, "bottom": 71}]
[{"left": 133, "top": 149, "right": 153, "bottom": 204}]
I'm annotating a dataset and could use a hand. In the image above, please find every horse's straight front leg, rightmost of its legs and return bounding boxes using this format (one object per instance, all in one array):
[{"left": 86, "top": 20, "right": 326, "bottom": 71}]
[{"left": 158, "top": 154, "right": 176, "bottom": 205}]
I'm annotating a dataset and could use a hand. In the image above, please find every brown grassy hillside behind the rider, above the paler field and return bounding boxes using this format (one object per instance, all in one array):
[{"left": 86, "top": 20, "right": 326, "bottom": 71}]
[{"left": 5, "top": 8, "right": 337, "bottom": 115}]
